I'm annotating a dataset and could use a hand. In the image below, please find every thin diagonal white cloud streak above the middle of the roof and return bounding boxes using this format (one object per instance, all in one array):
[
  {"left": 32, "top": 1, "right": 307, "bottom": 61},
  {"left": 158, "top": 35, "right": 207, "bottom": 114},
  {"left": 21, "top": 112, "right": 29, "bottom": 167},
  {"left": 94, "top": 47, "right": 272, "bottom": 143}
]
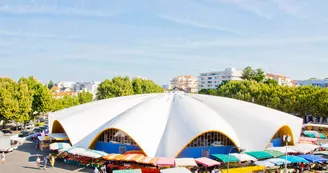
[{"left": 159, "top": 15, "right": 246, "bottom": 35}]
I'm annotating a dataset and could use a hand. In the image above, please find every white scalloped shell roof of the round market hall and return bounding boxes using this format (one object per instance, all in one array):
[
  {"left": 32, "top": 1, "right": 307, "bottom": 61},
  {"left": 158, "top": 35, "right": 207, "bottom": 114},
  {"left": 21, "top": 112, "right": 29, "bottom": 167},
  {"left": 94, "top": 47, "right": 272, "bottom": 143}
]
[{"left": 49, "top": 93, "right": 302, "bottom": 157}]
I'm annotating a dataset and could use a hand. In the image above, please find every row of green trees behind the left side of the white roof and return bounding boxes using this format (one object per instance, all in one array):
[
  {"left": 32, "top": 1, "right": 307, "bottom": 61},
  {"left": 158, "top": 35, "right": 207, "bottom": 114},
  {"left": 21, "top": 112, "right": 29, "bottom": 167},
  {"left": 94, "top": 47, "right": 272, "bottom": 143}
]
[{"left": 0, "top": 77, "right": 163, "bottom": 128}]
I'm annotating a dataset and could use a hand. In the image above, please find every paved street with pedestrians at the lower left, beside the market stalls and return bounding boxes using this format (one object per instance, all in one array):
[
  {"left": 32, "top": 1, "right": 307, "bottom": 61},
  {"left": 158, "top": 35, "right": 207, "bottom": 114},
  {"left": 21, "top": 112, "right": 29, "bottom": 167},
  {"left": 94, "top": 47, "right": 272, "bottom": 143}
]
[{"left": 0, "top": 141, "right": 92, "bottom": 173}]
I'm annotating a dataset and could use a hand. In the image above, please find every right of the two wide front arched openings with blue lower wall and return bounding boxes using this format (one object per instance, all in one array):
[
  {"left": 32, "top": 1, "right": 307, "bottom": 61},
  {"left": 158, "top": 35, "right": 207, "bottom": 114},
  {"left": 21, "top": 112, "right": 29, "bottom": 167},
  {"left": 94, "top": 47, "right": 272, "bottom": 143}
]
[{"left": 175, "top": 131, "right": 238, "bottom": 158}]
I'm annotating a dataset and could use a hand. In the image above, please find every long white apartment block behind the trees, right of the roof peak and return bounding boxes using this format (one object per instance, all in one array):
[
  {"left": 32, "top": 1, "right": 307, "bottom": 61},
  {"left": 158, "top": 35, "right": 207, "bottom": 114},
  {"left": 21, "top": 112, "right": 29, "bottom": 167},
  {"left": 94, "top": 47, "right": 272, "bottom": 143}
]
[{"left": 198, "top": 68, "right": 242, "bottom": 90}]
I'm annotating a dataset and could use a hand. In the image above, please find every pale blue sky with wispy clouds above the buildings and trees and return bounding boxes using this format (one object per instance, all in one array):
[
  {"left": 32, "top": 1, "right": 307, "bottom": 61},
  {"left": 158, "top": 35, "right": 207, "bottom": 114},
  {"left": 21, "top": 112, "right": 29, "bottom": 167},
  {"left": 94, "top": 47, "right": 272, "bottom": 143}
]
[{"left": 0, "top": 0, "right": 328, "bottom": 84}]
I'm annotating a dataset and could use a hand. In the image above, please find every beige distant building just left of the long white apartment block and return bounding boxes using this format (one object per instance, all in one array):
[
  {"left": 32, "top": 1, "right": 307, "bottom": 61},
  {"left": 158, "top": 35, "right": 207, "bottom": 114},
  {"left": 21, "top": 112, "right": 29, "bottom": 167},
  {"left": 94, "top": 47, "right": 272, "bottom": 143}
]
[{"left": 171, "top": 75, "right": 198, "bottom": 93}]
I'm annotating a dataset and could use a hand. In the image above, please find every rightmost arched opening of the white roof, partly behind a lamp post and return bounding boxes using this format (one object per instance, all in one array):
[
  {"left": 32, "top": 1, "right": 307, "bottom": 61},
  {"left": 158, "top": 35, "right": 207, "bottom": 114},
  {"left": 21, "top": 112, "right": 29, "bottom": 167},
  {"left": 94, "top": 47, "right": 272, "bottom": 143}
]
[{"left": 266, "top": 125, "right": 295, "bottom": 148}]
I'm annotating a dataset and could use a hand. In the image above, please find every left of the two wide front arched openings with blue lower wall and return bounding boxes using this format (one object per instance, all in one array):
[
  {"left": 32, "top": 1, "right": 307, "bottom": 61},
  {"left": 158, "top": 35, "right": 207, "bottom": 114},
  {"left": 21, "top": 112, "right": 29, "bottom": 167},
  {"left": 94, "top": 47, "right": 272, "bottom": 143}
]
[{"left": 89, "top": 128, "right": 145, "bottom": 154}]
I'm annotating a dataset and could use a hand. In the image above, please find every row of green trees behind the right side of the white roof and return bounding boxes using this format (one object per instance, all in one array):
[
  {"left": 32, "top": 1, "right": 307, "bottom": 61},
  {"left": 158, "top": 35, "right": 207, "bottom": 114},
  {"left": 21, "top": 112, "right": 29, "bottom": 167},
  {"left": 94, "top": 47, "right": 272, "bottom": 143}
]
[{"left": 200, "top": 68, "right": 328, "bottom": 117}]
